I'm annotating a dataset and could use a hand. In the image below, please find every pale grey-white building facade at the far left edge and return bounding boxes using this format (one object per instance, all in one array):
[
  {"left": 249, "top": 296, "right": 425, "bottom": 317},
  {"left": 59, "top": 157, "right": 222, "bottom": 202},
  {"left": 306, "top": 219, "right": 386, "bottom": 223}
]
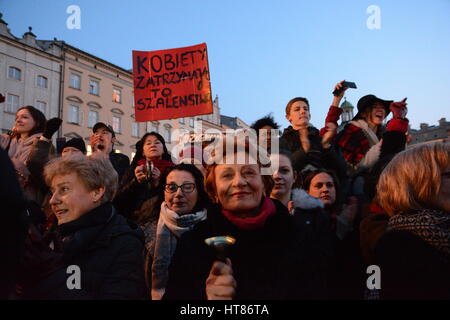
[{"left": 0, "top": 16, "right": 62, "bottom": 133}]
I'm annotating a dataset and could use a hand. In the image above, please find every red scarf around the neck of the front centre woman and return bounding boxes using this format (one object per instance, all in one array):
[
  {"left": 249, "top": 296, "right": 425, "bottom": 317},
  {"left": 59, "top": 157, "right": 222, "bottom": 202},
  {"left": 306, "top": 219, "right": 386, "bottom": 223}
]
[{"left": 221, "top": 197, "right": 276, "bottom": 231}]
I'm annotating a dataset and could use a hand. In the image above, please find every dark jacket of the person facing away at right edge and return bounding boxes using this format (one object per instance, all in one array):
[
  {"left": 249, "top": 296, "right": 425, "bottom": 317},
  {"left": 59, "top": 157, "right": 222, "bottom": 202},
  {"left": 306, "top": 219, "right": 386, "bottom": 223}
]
[{"left": 375, "top": 230, "right": 450, "bottom": 300}]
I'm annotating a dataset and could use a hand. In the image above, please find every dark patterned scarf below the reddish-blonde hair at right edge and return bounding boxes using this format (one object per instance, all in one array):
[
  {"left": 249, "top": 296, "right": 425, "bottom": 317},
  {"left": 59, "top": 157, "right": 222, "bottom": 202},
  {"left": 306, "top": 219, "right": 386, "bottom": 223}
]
[{"left": 387, "top": 209, "right": 450, "bottom": 254}]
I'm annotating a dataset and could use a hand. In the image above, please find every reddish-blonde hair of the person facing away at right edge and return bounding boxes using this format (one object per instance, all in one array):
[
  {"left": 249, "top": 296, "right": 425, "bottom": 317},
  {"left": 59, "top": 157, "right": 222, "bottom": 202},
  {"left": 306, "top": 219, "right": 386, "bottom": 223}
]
[{"left": 377, "top": 143, "right": 450, "bottom": 216}]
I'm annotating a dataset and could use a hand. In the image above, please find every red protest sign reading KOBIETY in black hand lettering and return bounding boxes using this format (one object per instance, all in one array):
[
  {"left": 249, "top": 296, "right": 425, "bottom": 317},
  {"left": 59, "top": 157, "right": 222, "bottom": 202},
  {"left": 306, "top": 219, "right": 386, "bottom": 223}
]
[{"left": 133, "top": 43, "right": 213, "bottom": 122}]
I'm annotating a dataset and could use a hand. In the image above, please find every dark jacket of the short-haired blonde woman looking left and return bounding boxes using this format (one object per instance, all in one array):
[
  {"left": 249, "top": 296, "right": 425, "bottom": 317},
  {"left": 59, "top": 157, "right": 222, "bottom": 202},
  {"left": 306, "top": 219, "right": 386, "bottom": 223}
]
[{"left": 24, "top": 203, "right": 148, "bottom": 300}]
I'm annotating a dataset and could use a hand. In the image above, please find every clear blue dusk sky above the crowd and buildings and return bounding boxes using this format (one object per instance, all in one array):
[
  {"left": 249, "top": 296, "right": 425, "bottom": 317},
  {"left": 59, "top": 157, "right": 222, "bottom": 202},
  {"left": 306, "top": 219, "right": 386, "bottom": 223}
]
[{"left": 0, "top": 0, "right": 450, "bottom": 128}]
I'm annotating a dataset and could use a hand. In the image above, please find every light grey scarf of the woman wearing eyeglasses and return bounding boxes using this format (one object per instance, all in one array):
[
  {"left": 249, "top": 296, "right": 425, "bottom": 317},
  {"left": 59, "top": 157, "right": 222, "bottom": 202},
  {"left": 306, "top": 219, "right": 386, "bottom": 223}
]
[{"left": 152, "top": 202, "right": 206, "bottom": 300}]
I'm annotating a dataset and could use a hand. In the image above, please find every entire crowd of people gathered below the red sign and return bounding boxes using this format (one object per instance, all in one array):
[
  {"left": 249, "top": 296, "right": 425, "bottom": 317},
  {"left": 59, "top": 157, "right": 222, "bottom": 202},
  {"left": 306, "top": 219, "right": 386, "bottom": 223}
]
[{"left": 0, "top": 82, "right": 450, "bottom": 300}]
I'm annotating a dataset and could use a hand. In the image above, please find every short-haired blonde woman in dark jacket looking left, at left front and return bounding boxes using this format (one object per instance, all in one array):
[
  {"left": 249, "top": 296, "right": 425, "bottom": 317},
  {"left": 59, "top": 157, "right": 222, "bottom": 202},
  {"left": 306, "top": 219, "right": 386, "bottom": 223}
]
[{"left": 17, "top": 156, "right": 145, "bottom": 299}]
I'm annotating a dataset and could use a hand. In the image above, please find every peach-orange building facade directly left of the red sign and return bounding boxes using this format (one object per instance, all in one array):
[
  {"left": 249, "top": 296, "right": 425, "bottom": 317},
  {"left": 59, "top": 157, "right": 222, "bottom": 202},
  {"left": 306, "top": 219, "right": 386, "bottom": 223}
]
[{"left": 55, "top": 43, "right": 140, "bottom": 156}]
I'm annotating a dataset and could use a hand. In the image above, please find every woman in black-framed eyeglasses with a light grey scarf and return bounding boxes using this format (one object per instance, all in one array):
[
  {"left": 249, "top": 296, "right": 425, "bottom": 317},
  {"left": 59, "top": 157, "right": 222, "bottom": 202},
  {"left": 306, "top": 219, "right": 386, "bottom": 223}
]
[{"left": 144, "top": 164, "right": 213, "bottom": 300}]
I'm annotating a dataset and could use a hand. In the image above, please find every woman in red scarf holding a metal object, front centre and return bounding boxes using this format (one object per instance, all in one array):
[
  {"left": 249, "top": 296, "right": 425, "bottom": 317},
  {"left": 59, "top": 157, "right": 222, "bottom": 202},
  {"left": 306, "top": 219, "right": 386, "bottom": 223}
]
[{"left": 165, "top": 138, "right": 324, "bottom": 300}]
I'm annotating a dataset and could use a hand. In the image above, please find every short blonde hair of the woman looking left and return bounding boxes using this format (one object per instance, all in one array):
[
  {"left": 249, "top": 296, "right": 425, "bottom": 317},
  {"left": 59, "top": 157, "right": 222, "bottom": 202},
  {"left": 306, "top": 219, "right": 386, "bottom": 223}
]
[{"left": 44, "top": 154, "right": 119, "bottom": 203}]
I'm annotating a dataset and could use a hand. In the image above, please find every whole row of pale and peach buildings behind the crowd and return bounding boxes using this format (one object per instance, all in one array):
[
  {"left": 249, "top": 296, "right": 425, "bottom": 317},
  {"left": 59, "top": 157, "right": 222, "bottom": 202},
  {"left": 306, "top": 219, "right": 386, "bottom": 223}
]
[{"left": 0, "top": 14, "right": 237, "bottom": 157}]
